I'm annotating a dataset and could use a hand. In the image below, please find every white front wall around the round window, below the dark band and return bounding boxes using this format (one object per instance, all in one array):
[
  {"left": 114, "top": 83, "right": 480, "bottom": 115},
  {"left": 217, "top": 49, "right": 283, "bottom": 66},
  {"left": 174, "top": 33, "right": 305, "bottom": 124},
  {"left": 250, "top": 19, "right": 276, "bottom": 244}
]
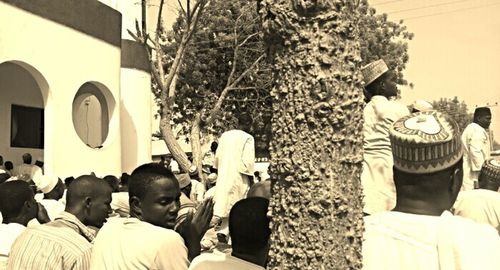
[{"left": 0, "top": 2, "right": 122, "bottom": 177}]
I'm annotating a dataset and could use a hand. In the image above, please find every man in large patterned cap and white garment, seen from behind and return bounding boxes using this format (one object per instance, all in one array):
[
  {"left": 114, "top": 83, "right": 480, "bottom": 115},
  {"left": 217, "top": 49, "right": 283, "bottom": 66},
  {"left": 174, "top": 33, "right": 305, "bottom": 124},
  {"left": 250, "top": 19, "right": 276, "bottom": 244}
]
[{"left": 363, "top": 111, "right": 500, "bottom": 270}]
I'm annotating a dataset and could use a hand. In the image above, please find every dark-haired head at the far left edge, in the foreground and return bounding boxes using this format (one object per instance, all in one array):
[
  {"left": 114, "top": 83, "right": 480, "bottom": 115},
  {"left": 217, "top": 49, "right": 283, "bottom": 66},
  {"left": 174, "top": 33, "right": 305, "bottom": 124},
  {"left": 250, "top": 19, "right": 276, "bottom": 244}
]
[{"left": 0, "top": 180, "right": 34, "bottom": 223}]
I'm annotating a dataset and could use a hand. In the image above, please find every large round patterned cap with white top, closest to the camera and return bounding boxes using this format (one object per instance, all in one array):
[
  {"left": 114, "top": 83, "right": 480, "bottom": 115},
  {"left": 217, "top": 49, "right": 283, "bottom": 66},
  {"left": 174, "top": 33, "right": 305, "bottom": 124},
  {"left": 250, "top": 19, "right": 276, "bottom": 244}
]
[{"left": 389, "top": 111, "right": 463, "bottom": 174}]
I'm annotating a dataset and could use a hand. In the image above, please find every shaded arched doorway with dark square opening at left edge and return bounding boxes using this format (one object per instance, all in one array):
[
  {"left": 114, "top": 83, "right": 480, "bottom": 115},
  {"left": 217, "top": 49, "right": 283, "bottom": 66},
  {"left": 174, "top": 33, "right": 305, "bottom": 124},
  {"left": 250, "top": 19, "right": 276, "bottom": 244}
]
[{"left": 0, "top": 61, "right": 49, "bottom": 167}]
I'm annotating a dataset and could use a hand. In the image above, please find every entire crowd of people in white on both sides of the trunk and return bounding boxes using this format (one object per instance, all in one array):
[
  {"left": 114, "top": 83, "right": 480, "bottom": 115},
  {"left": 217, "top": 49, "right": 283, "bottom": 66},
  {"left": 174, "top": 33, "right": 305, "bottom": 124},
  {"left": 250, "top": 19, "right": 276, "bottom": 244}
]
[{"left": 0, "top": 60, "right": 500, "bottom": 270}]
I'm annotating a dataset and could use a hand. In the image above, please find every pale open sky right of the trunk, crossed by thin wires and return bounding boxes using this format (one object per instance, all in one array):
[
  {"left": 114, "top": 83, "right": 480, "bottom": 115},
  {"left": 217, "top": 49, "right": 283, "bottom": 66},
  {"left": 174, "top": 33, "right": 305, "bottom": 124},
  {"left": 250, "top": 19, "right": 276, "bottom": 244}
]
[{"left": 369, "top": 0, "right": 500, "bottom": 141}]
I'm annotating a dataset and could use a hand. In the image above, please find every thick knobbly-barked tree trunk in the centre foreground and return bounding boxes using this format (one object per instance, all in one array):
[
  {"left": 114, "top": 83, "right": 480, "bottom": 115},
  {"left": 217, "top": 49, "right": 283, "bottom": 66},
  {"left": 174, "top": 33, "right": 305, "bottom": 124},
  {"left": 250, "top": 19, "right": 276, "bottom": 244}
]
[{"left": 259, "top": 0, "right": 363, "bottom": 269}]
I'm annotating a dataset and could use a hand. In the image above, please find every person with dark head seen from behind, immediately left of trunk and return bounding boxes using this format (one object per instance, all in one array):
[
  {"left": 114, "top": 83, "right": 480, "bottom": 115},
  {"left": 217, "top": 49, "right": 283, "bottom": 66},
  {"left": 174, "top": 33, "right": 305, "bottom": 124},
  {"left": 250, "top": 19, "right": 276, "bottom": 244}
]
[{"left": 189, "top": 197, "right": 271, "bottom": 270}]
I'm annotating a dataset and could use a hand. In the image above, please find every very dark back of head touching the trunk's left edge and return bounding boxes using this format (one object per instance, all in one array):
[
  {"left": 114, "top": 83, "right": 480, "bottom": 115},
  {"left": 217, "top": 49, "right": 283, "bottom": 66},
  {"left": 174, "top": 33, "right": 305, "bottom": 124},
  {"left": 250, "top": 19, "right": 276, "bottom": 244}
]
[{"left": 229, "top": 197, "right": 271, "bottom": 254}]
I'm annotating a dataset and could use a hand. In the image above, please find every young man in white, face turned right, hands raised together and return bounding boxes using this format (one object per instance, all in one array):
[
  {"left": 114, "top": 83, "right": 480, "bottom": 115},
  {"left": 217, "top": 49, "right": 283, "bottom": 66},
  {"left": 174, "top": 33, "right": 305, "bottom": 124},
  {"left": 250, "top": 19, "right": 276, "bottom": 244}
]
[{"left": 91, "top": 163, "right": 213, "bottom": 270}]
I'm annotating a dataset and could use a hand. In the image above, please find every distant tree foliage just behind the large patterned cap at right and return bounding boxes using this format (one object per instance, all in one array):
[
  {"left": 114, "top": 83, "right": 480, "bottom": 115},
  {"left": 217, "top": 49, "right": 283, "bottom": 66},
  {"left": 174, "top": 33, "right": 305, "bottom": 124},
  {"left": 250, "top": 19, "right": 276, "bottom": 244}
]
[{"left": 432, "top": 97, "right": 472, "bottom": 133}]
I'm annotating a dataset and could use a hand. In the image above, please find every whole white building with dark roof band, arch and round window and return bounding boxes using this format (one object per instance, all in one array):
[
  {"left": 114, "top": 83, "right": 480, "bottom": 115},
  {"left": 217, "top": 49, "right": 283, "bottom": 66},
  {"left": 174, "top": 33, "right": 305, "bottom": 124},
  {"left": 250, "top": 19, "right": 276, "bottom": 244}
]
[{"left": 0, "top": 0, "right": 152, "bottom": 177}]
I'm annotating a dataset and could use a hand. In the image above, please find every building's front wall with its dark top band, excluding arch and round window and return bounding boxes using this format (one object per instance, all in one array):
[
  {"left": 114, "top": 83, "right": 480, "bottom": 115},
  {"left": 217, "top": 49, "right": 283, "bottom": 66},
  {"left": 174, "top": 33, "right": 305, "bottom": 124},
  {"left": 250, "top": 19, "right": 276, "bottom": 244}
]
[{"left": 0, "top": 0, "right": 122, "bottom": 177}]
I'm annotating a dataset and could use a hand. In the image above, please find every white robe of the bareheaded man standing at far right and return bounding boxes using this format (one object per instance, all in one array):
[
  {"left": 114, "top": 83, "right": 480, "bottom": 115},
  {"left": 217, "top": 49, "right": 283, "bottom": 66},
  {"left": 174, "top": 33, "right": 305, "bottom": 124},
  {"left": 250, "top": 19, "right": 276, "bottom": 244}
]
[{"left": 462, "top": 123, "right": 491, "bottom": 191}]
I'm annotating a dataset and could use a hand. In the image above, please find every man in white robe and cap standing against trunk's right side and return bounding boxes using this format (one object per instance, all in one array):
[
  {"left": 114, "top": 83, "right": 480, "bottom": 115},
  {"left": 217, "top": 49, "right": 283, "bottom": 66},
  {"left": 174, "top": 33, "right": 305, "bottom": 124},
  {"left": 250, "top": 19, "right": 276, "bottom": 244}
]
[{"left": 361, "top": 60, "right": 409, "bottom": 214}]
